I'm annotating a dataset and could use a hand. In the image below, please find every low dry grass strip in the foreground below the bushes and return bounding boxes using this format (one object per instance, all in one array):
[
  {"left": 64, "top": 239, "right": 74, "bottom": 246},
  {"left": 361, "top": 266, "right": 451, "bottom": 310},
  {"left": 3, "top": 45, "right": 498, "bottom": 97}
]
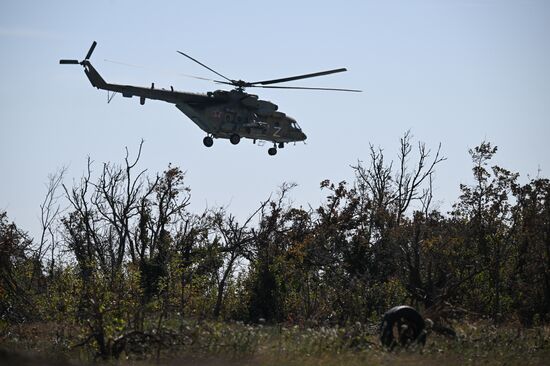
[{"left": 0, "top": 321, "right": 550, "bottom": 366}]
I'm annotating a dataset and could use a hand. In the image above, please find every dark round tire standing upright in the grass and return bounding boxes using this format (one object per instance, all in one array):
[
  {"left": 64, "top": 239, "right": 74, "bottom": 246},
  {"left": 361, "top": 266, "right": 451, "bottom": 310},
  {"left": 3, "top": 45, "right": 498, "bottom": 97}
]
[{"left": 380, "top": 305, "right": 426, "bottom": 349}]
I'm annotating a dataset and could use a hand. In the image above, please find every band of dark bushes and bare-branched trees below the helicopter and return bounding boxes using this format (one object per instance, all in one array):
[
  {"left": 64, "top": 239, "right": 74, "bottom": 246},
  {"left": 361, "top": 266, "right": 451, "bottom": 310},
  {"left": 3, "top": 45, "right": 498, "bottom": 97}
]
[{"left": 0, "top": 133, "right": 550, "bottom": 360}]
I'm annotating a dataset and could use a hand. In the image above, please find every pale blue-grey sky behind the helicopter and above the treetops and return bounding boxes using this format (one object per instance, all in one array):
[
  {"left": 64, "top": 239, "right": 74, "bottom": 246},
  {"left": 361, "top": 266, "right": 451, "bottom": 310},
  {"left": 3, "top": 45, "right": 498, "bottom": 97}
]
[{"left": 0, "top": 0, "right": 550, "bottom": 239}]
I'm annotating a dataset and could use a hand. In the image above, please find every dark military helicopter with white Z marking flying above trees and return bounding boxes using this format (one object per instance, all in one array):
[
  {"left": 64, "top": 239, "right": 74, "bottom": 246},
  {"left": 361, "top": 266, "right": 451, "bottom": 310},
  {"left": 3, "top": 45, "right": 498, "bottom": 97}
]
[{"left": 59, "top": 41, "right": 361, "bottom": 155}]
